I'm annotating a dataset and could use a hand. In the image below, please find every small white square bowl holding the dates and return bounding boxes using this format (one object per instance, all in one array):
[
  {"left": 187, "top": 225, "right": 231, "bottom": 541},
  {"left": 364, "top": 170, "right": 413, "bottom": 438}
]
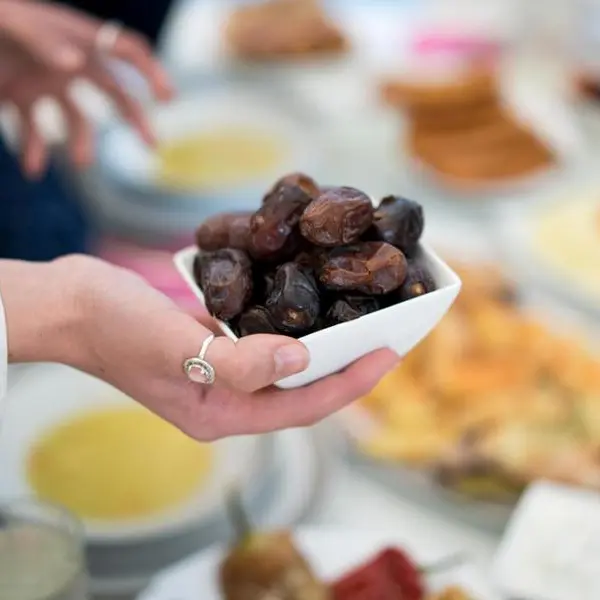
[{"left": 174, "top": 244, "right": 461, "bottom": 389}]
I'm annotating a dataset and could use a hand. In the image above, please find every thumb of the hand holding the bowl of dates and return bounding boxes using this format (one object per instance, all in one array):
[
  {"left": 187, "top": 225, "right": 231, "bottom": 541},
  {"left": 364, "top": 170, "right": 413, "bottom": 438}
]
[{"left": 206, "top": 335, "right": 310, "bottom": 392}]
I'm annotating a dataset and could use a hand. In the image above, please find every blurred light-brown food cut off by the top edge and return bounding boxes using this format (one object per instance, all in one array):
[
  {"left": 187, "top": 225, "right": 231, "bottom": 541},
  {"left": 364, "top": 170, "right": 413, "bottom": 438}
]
[{"left": 224, "top": 0, "right": 348, "bottom": 61}]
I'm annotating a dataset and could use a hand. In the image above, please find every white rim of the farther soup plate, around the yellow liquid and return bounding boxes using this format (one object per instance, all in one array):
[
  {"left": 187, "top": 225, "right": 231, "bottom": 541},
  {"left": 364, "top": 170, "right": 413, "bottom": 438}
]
[{"left": 97, "top": 83, "right": 318, "bottom": 204}]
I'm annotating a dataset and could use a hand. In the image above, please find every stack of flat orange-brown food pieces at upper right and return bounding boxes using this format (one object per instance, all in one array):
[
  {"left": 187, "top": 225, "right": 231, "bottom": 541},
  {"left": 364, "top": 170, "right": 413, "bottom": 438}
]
[{"left": 382, "top": 70, "right": 555, "bottom": 185}]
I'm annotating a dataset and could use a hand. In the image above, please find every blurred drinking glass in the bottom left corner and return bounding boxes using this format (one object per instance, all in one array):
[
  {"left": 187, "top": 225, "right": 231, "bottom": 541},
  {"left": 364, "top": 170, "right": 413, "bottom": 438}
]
[{"left": 0, "top": 500, "right": 89, "bottom": 600}]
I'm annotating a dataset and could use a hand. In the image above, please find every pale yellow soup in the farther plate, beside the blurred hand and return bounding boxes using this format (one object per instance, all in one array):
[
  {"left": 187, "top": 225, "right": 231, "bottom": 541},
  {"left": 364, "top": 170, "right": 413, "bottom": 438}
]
[{"left": 156, "top": 126, "right": 288, "bottom": 190}]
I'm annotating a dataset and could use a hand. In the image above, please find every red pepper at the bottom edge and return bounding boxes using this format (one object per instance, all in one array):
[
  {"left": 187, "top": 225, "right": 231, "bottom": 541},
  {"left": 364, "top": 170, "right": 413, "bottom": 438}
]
[{"left": 332, "top": 548, "right": 425, "bottom": 600}]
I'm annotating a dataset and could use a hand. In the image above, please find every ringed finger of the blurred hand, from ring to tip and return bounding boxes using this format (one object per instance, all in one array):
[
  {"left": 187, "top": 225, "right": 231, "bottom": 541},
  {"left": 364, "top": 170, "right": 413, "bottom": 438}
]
[{"left": 111, "top": 32, "right": 173, "bottom": 101}]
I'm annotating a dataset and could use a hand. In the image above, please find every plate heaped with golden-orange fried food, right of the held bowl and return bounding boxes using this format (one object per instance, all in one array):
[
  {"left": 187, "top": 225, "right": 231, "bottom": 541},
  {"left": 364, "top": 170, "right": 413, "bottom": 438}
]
[{"left": 339, "top": 227, "right": 600, "bottom": 533}]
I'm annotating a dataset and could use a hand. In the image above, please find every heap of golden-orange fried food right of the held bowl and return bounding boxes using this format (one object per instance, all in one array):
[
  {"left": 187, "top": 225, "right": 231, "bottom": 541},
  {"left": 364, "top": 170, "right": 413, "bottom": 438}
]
[{"left": 361, "top": 266, "right": 600, "bottom": 498}]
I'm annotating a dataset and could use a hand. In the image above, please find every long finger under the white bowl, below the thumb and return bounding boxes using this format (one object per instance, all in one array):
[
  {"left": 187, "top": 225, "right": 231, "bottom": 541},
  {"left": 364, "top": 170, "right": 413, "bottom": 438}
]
[{"left": 232, "top": 349, "right": 400, "bottom": 433}]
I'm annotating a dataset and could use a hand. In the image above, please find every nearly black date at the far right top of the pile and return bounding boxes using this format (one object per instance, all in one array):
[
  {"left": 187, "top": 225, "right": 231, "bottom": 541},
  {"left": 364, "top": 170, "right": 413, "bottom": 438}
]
[{"left": 373, "top": 196, "right": 425, "bottom": 254}]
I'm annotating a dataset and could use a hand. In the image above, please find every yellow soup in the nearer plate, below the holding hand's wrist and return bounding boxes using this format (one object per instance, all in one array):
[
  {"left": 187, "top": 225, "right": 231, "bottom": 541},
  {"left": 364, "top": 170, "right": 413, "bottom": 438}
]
[{"left": 27, "top": 407, "right": 213, "bottom": 521}]
